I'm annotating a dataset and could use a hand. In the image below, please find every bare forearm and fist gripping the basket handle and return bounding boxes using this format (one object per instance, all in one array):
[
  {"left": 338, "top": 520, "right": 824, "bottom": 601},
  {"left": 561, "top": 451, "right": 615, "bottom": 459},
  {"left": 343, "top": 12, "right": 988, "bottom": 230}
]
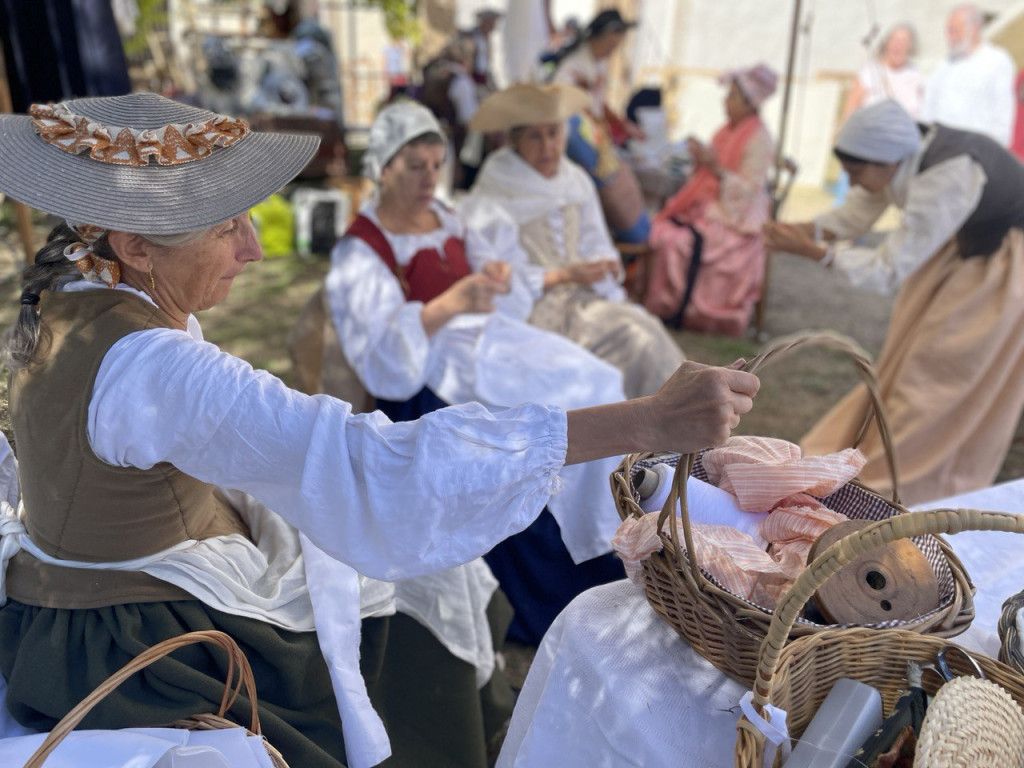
[{"left": 565, "top": 361, "right": 761, "bottom": 464}]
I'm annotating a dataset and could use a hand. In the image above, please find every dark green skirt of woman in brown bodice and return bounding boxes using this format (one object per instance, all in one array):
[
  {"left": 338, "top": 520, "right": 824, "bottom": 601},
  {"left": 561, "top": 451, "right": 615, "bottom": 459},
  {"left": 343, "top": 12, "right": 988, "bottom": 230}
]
[{"left": 0, "top": 600, "right": 350, "bottom": 768}]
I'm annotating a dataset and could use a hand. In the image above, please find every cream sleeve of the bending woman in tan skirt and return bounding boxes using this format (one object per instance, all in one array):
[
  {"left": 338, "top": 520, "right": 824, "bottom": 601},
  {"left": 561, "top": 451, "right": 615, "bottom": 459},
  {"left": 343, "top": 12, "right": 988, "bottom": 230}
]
[{"left": 833, "top": 155, "right": 987, "bottom": 293}]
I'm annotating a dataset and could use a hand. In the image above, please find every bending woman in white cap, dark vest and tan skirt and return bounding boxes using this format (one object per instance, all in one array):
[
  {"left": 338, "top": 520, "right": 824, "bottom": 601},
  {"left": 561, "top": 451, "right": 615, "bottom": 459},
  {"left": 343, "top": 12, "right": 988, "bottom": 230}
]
[{"left": 765, "top": 100, "right": 1024, "bottom": 504}]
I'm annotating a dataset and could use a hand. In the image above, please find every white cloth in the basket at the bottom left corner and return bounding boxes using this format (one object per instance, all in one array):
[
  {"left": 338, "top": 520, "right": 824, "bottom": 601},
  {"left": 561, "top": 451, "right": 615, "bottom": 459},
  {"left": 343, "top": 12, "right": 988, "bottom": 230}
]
[{"left": 0, "top": 728, "right": 273, "bottom": 768}]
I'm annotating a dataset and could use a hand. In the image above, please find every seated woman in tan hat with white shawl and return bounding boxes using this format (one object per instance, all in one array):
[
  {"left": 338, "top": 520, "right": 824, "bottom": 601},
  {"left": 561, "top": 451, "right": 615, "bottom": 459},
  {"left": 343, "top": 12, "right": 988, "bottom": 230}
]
[{"left": 460, "top": 83, "right": 684, "bottom": 397}]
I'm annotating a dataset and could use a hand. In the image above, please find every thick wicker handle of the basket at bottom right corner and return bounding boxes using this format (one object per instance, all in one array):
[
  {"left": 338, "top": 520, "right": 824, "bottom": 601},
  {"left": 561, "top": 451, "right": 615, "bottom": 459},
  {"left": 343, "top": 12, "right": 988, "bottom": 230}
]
[{"left": 753, "top": 509, "right": 1024, "bottom": 713}]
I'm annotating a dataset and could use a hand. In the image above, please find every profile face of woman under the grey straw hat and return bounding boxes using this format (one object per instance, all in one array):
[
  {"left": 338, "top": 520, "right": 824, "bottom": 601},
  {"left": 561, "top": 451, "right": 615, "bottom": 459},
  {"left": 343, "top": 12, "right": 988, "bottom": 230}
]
[{"left": 151, "top": 211, "right": 263, "bottom": 312}]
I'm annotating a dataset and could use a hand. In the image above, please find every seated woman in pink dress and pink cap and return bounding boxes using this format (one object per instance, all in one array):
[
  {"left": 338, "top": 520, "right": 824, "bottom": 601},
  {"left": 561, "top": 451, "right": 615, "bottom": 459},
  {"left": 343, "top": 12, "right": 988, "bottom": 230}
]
[{"left": 643, "top": 65, "right": 776, "bottom": 336}]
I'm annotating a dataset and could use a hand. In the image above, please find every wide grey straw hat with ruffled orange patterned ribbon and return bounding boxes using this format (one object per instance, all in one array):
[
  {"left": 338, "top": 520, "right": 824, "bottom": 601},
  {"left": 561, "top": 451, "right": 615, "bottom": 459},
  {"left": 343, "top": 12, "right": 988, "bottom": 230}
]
[{"left": 0, "top": 93, "right": 319, "bottom": 234}]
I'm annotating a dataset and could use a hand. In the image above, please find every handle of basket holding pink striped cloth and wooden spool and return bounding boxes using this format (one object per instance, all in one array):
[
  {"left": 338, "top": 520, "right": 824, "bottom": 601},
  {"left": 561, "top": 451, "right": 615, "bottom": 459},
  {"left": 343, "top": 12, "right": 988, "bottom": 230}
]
[{"left": 651, "top": 331, "right": 899, "bottom": 587}]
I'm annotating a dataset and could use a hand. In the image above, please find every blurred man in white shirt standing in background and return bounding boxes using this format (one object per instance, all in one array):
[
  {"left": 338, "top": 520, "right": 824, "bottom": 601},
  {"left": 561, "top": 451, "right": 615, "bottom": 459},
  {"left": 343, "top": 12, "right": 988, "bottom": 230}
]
[{"left": 922, "top": 4, "right": 1015, "bottom": 146}]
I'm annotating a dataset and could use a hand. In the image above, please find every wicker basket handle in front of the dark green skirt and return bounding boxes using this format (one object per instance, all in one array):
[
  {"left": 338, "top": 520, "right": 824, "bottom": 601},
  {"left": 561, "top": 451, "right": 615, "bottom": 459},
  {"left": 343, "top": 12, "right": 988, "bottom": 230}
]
[{"left": 25, "top": 630, "right": 288, "bottom": 768}]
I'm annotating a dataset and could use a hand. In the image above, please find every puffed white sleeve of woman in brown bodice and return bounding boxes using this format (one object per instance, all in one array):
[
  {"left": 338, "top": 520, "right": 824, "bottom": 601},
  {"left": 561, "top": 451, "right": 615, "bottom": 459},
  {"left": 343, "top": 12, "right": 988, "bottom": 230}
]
[{"left": 87, "top": 329, "right": 567, "bottom": 581}]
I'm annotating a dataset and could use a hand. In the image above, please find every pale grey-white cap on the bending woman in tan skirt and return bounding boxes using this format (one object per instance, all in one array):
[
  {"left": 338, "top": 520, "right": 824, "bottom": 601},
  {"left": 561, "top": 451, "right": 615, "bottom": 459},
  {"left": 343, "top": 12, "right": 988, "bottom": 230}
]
[{"left": 836, "top": 98, "right": 921, "bottom": 163}]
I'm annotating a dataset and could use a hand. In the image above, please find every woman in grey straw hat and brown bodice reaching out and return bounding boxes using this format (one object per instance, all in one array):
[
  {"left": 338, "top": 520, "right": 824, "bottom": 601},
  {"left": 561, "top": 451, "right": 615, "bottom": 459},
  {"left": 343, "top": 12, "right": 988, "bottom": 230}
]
[{"left": 0, "top": 94, "right": 757, "bottom": 766}]
